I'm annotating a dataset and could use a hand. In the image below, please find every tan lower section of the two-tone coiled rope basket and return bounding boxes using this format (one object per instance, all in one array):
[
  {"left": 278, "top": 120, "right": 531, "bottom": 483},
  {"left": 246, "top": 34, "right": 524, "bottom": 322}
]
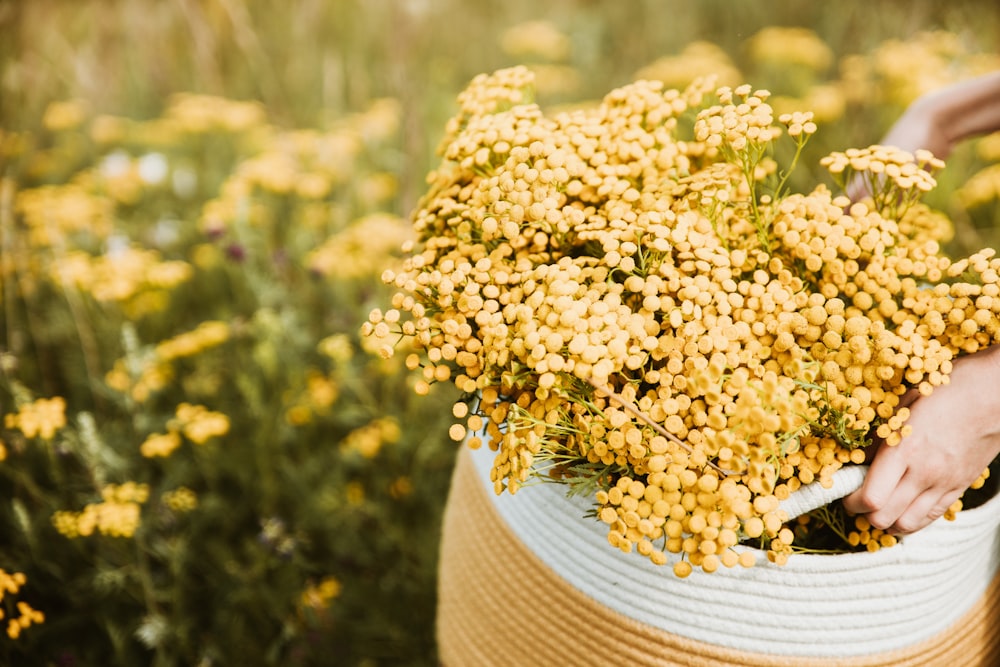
[{"left": 437, "top": 450, "right": 1000, "bottom": 667}]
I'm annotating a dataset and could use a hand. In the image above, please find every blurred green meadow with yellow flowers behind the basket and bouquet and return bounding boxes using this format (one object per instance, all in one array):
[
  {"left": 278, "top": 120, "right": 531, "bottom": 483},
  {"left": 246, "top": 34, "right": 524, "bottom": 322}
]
[{"left": 0, "top": 0, "right": 1000, "bottom": 666}]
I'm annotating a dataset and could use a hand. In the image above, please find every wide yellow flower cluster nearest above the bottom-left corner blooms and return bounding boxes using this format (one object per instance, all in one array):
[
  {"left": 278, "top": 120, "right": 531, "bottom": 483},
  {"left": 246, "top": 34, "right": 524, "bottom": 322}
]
[{"left": 52, "top": 482, "right": 149, "bottom": 538}]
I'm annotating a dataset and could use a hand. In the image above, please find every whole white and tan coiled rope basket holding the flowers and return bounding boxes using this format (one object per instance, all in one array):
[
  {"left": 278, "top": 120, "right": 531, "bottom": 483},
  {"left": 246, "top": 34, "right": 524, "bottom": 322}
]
[{"left": 437, "top": 449, "right": 1000, "bottom": 667}]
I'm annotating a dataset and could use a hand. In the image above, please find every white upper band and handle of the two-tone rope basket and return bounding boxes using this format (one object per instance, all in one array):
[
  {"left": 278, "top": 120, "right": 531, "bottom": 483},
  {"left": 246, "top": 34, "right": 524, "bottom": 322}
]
[{"left": 471, "top": 440, "right": 1000, "bottom": 658}]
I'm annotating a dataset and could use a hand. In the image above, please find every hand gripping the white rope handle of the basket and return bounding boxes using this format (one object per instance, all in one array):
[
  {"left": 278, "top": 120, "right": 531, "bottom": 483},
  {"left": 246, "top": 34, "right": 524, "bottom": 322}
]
[{"left": 844, "top": 346, "right": 1000, "bottom": 534}]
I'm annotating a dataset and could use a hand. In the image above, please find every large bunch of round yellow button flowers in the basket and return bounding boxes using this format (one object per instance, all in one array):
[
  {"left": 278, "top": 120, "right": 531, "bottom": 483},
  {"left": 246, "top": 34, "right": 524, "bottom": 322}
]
[{"left": 364, "top": 68, "right": 1000, "bottom": 576}]
